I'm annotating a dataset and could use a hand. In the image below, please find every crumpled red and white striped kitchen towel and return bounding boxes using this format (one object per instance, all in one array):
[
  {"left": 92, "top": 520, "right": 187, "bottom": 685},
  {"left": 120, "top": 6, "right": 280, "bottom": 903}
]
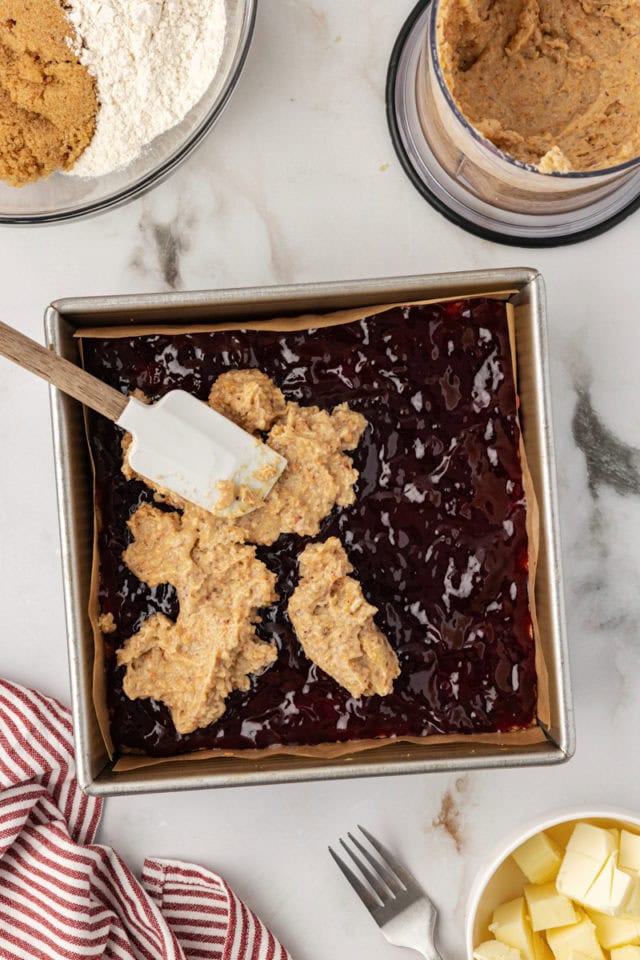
[{"left": 0, "top": 680, "right": 290, "bottom": 960}]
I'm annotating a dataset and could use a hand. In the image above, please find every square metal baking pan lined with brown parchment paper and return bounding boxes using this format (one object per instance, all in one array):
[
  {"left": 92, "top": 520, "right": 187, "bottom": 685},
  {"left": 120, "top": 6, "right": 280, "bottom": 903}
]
[{"left": 45, "top": 268, "right": 574, "bottom": 796}]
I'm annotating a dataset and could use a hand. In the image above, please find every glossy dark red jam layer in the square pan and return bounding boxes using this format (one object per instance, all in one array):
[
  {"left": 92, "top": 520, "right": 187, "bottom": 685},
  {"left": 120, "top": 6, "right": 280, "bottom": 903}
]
[{"left": 84, "top": 300, "right": 536, "bottom": 756}]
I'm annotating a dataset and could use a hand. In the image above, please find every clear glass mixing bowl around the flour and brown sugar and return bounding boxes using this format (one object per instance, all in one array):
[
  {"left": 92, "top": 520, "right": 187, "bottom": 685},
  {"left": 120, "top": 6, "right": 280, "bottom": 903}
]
[{"left": 0, "top": 0, "right": 257, "bottom": 224}]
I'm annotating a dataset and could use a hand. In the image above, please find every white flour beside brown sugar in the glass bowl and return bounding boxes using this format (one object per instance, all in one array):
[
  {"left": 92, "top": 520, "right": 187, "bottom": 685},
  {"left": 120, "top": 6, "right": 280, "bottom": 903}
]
[{"left": 66, "top": 0, "right": 226, "bottom": 177}]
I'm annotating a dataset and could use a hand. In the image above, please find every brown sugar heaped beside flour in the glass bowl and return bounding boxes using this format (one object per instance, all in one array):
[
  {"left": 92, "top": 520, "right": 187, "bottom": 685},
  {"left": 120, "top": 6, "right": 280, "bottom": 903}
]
[{"left": 0, "top": 0, "right": 98, "bottom": 186}]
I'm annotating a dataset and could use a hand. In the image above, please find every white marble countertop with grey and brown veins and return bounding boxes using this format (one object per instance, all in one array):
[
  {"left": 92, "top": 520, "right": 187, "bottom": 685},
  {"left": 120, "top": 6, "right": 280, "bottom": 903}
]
[{"left": 0, "top": 0, "right": 640, "bottom": 960}]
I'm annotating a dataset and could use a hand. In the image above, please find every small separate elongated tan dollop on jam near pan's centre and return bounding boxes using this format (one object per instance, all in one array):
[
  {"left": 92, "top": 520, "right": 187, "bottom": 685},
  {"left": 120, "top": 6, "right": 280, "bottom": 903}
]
[{"left": 289, "top": 537, "right": 400, "bottom": 699}]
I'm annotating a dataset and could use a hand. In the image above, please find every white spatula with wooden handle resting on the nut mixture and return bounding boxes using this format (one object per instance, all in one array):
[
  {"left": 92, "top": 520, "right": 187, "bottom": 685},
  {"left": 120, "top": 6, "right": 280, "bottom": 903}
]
[{"left": 0, "top": 322, "right": 287, "bottom": 516}]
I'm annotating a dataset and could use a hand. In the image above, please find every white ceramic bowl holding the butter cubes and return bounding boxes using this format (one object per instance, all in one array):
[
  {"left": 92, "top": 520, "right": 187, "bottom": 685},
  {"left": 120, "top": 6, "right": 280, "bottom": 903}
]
[{"left": 465, "top": 807, "right": 640, "bottom": 960}]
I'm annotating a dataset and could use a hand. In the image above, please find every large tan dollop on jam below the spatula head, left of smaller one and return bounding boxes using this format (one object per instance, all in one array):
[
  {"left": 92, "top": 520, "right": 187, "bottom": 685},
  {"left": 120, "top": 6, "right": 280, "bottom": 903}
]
[{"left": 118, "top": 504, "right": 277, "bottom": 733}]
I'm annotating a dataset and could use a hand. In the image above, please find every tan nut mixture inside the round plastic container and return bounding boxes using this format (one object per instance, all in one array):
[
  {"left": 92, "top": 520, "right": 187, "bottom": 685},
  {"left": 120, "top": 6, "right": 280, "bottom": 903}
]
[{"left": 437, "top": 0, "right": 640, "bottom": 173}]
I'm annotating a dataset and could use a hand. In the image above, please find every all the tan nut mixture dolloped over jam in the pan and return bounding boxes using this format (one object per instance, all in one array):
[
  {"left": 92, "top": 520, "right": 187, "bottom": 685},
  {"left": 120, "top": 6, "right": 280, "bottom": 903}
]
[{"left": 114, "top": 370, "right": 399, "bottom": 733}]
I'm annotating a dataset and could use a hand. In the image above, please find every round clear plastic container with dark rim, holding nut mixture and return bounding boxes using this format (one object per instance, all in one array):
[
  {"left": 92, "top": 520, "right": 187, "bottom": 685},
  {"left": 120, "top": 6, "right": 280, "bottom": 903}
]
[{"left": 388, "top": 0, "right": 640, "bottom": 246}]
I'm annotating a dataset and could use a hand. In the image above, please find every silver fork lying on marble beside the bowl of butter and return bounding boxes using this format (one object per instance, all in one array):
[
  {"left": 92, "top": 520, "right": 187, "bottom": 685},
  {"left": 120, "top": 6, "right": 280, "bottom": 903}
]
[{"left": 329, "top": 826, "right": 442, "bottom": 960}]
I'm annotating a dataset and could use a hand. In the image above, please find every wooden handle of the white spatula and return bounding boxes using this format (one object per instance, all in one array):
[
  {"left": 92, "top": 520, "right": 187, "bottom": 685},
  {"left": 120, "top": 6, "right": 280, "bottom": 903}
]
[{"left": 0, "top": 321, "right": 129, "bottom": 420}]
